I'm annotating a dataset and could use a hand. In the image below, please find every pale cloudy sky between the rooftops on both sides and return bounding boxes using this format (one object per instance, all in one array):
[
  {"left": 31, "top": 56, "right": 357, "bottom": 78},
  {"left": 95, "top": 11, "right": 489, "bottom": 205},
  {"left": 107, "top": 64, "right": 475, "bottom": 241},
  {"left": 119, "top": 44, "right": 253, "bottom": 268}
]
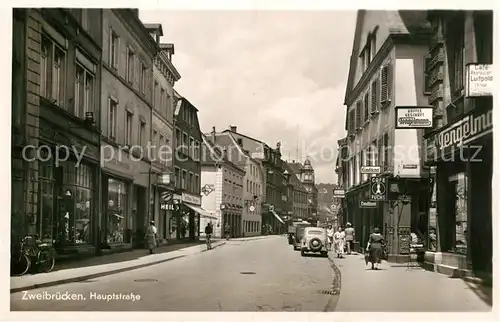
[{"left": 140, "top": 9, "right": 356, "bottom": 183}]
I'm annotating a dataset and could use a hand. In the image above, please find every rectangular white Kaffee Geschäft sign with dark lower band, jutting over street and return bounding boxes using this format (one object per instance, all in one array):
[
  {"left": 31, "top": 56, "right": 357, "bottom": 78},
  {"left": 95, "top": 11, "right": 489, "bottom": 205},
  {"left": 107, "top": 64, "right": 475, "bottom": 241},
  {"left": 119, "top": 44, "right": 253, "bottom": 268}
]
[{"left": 395, "top": 106, "right": 434, "bottom": 129}]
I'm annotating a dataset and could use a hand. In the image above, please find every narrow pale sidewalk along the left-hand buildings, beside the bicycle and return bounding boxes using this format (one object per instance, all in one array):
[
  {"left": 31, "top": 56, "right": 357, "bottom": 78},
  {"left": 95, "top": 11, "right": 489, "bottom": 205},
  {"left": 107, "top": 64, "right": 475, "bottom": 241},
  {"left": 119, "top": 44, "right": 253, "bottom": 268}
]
[{"left": 10, "top": 240, "right": 226, "bottom": 293}]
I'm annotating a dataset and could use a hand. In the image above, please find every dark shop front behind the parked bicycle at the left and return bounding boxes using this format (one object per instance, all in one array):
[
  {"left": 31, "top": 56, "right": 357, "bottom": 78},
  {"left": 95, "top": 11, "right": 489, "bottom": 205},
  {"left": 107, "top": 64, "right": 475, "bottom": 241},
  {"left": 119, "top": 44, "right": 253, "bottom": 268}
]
[{"left": 36, "top": 114, "right": 99, "bottom": 256}]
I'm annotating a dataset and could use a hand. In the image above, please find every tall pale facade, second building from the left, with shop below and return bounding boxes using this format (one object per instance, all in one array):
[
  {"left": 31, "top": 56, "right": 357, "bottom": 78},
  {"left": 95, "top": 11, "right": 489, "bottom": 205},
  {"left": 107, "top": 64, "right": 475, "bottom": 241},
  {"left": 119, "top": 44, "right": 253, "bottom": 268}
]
[{"left": 100, "top": 9, "right": 158, "bottom": 249}]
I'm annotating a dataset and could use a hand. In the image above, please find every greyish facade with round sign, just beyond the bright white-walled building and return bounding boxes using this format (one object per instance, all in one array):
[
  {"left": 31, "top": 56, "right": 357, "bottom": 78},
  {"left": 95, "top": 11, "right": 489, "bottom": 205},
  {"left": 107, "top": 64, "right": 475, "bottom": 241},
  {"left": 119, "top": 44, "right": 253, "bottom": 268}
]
[{"left": 207, "top": 127, "right": 264, "bottom": 236}]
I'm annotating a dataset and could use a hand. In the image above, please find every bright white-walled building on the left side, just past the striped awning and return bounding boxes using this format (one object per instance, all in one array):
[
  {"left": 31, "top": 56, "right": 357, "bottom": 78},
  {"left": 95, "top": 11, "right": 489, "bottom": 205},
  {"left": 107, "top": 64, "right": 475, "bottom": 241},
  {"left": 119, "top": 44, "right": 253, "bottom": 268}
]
[{"left": 201, "top": 133, "right": 245, "bottom": 237}]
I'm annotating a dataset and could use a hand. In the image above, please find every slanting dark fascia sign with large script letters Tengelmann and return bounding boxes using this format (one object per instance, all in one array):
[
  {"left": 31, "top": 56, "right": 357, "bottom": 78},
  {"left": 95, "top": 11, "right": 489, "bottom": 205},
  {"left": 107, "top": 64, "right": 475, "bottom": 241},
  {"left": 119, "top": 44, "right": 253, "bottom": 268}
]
[{"left": 436, "top": 105, "right": 493, "bottom": 156}]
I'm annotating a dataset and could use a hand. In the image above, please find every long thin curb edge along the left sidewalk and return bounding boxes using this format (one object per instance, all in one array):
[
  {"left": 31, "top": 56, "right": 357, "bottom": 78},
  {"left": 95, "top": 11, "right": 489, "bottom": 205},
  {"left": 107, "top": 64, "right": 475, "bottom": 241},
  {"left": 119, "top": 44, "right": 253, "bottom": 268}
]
[{"left": 10, "top": 242, "right": 226, "bottom": 294}]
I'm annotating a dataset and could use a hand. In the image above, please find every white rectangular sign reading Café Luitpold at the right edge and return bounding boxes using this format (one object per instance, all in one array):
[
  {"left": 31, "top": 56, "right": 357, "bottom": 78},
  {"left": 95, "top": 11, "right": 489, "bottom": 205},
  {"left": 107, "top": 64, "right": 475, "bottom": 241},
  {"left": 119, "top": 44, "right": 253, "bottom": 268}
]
[{"left": 465, "top": 64, "right": 493, "bottom": 97}]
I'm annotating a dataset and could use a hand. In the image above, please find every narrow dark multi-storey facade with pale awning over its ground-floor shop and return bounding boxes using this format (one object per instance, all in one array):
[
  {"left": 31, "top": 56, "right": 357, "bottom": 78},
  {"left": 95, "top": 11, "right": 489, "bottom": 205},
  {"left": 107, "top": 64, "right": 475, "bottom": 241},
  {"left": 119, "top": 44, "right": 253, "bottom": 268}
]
[{"left": 170, "top": 91, "right": 205, "bottom": 239}]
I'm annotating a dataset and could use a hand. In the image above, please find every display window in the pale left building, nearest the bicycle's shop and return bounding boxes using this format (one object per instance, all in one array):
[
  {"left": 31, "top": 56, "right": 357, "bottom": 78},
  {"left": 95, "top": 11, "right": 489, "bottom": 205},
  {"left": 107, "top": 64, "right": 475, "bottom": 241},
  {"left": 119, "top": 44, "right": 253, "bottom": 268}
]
[{"left": 106, "top": 178, "right": 127, "bottom": 244}]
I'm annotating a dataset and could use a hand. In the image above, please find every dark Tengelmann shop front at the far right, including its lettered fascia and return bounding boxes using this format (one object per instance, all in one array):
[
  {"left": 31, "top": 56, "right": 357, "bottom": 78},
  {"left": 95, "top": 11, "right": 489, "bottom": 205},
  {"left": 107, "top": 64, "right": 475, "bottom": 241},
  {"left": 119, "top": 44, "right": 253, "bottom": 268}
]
[{"left": 425, "top": 104, "right": 493, "bottom": 275}]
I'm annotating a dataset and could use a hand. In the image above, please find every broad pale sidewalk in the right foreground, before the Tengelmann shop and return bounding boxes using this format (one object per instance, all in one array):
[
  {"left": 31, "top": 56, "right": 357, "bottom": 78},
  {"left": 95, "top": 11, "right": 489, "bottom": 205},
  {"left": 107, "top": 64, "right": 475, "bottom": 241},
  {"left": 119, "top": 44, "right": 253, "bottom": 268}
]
[{"left": 330, "top": 253, "right": 492, "bottom": 312}]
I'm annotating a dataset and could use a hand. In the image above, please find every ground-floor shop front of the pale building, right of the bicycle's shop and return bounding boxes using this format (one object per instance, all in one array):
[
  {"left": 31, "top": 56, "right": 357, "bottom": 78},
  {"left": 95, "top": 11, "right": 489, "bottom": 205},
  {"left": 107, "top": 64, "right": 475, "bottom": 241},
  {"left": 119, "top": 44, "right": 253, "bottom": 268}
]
[{"left": 100, "top": 146, "right": 149, "bottom": 251}]
